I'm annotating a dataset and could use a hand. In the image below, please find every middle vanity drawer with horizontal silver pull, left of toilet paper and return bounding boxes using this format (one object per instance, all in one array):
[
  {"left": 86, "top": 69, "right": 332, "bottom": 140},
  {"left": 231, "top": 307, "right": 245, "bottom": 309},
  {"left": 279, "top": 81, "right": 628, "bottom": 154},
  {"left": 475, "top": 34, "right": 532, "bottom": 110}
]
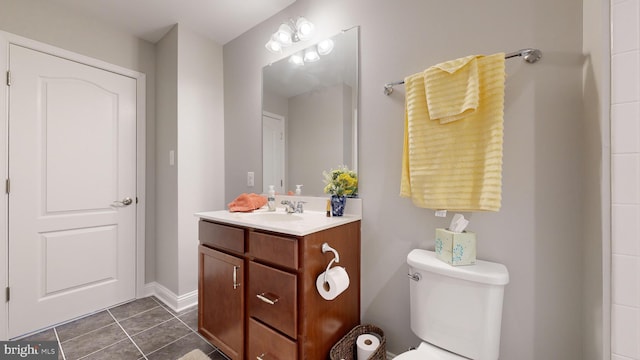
[{"left": 247, "top": 261, "right": 298, "bottom": 338}]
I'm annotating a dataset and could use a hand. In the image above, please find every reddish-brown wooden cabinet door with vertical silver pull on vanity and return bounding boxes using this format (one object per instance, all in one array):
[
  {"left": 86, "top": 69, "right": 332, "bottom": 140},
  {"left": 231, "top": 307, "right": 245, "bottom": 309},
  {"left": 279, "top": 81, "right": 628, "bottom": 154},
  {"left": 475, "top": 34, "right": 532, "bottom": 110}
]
[{"left": 198, "top": 245, "right": 244, "bottom": 360}]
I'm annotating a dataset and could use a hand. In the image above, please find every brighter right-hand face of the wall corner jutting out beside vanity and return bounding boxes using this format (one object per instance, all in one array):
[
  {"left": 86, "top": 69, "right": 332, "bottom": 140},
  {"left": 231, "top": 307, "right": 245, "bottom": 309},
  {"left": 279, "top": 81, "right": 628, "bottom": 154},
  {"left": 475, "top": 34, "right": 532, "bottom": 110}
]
[{"left": 175, "top": 25, "right": 225, "bottom": 295}]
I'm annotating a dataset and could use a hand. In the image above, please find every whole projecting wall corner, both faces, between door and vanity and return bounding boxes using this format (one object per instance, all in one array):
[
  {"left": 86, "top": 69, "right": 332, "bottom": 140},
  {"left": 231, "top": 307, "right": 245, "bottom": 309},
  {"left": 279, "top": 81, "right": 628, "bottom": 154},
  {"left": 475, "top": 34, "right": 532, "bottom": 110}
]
[{"left": 156, "top": 25, "right": 224, "bottom": 295}]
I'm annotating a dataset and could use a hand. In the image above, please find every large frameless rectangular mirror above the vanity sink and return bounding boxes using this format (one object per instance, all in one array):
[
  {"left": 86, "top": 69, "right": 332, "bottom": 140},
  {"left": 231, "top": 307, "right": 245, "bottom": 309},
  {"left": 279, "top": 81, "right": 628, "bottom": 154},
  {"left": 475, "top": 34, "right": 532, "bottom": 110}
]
[{"left": 262, "top": 27, "right": 359, "bottom": 196}]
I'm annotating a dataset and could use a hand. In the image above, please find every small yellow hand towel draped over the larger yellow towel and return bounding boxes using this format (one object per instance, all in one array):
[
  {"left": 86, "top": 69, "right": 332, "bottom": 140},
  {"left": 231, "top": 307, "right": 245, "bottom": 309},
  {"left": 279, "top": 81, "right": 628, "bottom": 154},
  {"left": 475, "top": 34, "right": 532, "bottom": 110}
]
[{"left": 424, "top": 56, "right": 480, "bottom": 124}]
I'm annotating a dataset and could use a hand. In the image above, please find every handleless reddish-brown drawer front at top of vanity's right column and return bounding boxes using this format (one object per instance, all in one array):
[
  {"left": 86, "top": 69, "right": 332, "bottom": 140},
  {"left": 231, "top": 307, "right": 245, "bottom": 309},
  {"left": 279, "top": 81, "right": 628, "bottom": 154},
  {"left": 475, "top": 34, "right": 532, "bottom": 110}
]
[{"left": 249, "top": 232, "right": 298, "bottom": 269}]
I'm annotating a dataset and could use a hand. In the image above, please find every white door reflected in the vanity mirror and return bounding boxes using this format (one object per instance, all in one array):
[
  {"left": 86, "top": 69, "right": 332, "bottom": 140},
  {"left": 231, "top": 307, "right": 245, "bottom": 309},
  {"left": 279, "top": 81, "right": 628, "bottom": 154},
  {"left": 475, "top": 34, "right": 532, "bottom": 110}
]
[{"left": 262, "top": 112, "right": 286, "bottom": 194}]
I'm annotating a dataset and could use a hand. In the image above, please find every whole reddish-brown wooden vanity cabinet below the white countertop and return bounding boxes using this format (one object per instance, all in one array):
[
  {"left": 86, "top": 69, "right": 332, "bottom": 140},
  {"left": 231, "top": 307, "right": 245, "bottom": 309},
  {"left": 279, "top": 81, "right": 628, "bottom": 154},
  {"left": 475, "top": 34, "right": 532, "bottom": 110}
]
[{"left": 198, "top": 219, "right": 360, "bottom": 360}]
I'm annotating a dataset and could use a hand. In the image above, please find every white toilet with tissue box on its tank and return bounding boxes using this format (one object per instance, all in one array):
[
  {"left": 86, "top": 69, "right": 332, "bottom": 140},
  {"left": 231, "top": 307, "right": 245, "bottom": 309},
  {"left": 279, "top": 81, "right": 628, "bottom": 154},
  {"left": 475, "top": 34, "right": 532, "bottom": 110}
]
[{"left": 394, "top": 249, "right": 509, "bottom": 360}]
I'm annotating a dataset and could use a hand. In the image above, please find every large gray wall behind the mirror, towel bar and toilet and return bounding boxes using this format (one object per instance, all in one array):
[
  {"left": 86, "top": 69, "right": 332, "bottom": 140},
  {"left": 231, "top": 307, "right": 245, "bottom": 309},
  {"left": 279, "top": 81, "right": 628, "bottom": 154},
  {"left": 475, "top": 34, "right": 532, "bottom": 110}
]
[{"left": 224, "top": 0, "right": 600, "bottom": 360}]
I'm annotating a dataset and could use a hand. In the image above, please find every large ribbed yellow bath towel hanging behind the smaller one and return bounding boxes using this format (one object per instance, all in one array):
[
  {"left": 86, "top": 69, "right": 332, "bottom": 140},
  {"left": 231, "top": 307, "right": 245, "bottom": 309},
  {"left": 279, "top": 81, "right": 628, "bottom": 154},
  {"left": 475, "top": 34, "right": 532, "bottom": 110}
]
[{"left": 400, "top": 53, "right": 505, "bottom": 211}]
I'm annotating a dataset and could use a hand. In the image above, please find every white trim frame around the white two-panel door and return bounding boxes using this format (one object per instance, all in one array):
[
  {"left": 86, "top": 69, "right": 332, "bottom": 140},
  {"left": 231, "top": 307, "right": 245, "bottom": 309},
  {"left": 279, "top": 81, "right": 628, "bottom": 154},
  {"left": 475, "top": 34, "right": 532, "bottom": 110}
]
[{"left": 0, "top": 31, "right": 147, "bottom": 341}]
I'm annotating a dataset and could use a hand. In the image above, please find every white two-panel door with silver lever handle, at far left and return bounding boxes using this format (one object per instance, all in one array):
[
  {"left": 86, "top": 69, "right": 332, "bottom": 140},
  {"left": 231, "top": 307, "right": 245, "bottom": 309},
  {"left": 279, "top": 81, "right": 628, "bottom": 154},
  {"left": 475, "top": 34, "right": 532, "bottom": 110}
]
[{"left": 9, "top": 45, "right": 136, "bottom": 338}]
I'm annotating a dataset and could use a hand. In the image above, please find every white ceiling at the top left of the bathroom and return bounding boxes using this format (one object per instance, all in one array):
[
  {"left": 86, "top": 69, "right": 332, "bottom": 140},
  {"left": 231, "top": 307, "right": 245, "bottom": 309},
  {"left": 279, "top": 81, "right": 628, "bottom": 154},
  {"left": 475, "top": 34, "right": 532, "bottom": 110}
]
[{"left": 49, "top": 0, "right": 296, "bottom": 45}]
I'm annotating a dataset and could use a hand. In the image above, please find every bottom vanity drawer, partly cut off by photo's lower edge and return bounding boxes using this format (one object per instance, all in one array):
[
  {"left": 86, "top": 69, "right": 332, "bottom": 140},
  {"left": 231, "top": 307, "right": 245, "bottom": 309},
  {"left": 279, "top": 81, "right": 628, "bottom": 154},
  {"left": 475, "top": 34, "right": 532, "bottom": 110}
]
[{"left": 247, "top": 319, "right": 298, "bottom": 360}]
